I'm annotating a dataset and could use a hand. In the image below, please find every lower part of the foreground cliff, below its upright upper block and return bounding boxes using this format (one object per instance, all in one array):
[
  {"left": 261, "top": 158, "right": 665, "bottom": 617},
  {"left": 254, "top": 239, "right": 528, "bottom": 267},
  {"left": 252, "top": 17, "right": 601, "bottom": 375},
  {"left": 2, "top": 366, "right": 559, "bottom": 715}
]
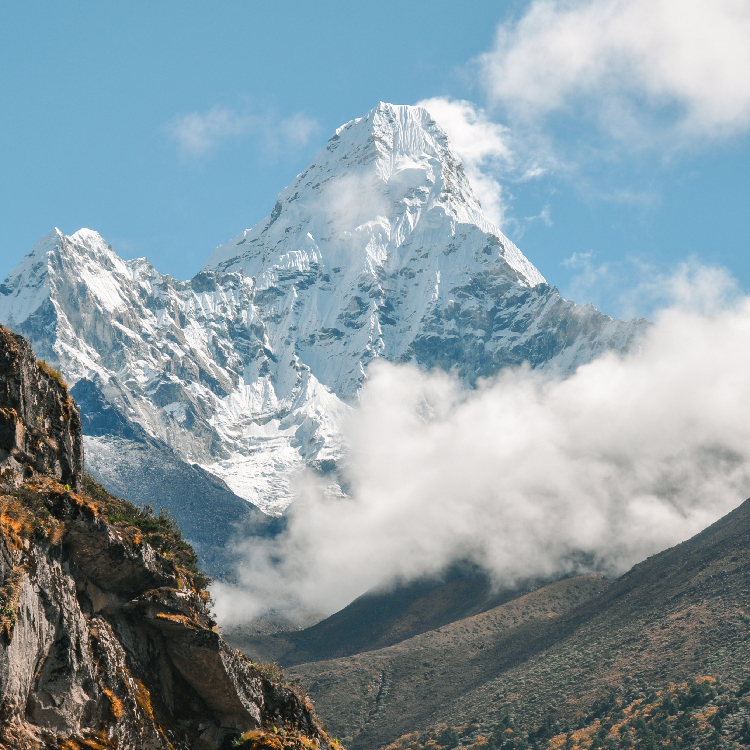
[{"left": 0, "top": 478, "right": 328, "bottom": 750}]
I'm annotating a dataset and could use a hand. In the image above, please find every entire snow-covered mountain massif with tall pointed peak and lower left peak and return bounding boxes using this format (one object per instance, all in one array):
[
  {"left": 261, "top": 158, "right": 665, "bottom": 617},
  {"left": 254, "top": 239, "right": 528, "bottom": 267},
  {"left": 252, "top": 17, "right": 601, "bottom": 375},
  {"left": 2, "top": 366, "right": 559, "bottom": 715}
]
[{"left": 0, "top": 104, "right": 644, "bottom": 513}]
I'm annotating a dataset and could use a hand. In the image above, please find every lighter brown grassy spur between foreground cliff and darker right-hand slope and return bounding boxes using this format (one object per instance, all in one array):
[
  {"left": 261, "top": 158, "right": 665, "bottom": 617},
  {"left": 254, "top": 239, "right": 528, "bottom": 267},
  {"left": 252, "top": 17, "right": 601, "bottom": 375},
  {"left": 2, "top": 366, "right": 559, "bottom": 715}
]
[{"left": 288, "top": 576, "right": 608, "bottom": 747}]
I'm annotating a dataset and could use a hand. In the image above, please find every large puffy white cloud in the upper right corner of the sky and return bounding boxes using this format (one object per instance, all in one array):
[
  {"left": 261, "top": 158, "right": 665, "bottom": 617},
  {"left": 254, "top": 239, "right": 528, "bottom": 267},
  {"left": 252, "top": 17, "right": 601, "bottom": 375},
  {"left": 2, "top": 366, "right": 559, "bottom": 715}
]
[{"left": 479, "top": 0, "right": 750, "bottom": 138}]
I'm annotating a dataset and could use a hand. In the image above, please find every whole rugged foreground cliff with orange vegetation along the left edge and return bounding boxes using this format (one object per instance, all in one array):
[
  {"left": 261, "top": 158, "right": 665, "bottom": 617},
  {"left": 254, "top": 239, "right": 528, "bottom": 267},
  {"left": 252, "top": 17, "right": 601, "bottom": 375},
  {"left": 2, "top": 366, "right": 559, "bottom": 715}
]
[{"left": 0, "top": 330, "right": 329, "bottom": 750}]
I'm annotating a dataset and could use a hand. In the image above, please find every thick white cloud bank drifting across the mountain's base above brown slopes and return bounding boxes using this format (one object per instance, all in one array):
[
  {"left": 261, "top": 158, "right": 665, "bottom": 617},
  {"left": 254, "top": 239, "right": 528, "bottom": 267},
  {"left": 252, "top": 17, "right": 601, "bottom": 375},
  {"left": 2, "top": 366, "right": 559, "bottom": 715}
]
[{"left": 214, "top": 268, "right": 750, "bottom": 623}]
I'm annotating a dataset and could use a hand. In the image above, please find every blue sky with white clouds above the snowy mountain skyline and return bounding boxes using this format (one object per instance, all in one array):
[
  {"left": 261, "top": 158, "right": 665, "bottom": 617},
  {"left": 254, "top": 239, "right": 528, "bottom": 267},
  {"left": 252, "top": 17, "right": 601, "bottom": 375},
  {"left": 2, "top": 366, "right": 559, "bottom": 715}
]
[{"left": 0, "top": 0, "right": 750, "bottom": 315}]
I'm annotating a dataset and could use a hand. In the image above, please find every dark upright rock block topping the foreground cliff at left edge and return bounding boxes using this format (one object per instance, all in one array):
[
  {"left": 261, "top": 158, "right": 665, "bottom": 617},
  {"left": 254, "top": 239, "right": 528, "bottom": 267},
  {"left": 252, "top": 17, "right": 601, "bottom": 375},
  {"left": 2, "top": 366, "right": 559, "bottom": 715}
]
[{"left": 0, "top": 327, "right": 83, "bottom": 489}]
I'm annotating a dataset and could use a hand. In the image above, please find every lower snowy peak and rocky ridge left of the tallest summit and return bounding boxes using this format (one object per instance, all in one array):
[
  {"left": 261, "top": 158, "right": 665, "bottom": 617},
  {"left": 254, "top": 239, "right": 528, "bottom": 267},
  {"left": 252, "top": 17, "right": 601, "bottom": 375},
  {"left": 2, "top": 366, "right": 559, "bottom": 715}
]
[{"left": 0, "top": 229, "right": 346, "bottom": 512}]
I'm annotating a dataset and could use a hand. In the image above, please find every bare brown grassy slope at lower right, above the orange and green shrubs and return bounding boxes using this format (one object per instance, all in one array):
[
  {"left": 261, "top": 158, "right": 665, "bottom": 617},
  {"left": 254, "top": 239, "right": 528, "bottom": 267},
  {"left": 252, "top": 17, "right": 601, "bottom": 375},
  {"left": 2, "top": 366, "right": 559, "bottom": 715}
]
[{"left": 290, "top": 503, "right": 750, "bottom": 749}]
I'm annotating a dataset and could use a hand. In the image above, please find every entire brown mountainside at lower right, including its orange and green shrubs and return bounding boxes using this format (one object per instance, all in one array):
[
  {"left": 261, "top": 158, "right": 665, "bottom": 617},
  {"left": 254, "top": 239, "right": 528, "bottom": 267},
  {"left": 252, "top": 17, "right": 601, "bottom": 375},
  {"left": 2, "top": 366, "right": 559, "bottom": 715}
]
[{"left": 290, "top": 494, "right": 750, "bottom": 750}]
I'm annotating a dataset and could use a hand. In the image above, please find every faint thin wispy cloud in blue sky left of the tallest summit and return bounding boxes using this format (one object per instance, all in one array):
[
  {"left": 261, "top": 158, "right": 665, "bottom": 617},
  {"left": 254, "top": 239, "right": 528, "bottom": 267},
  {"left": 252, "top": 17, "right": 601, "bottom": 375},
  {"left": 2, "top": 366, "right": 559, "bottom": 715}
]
[{"left": 165, "top": 106, "right": 320, "bottom": 157}]
